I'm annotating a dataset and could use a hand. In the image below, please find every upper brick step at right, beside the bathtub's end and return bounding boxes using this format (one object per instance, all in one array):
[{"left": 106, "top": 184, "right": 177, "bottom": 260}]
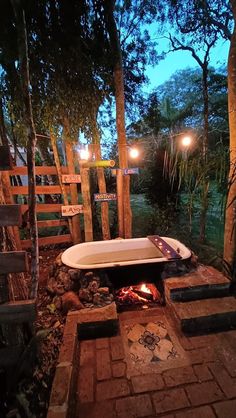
[{"left": 164, "top": 265, "right": 230, "bottom": 302}]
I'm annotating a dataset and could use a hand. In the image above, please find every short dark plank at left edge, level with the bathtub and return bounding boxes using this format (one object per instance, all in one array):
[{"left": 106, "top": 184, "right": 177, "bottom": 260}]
[{"left": 0, "top": 251, "right": 28, "bottom": 274}]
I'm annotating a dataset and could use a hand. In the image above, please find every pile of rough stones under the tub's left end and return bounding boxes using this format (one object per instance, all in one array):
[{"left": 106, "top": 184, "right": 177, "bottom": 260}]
[{"left": 47, "top": 253, "right": 113, "bottom": 313}]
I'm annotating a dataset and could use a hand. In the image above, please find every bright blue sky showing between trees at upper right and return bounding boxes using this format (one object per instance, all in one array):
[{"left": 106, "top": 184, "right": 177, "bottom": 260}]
[{"left": 144, "top": 39, "right": 229, "bottom": 92}]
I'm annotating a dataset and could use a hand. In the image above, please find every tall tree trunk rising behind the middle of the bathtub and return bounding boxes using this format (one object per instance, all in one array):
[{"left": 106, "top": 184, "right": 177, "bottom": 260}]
[{"left": 104, "top": 0, "right": 132, "bottom": 238}]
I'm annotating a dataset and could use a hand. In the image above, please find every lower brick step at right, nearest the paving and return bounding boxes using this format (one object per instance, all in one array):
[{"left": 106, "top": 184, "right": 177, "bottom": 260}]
[{"left": 171, "top": 296, "right": 236, "bottom": 335}]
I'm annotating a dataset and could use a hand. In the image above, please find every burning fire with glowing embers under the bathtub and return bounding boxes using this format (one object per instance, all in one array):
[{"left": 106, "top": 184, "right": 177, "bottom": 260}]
[{"left": 116, "top": 283, "right": 161, "bottom": 305}]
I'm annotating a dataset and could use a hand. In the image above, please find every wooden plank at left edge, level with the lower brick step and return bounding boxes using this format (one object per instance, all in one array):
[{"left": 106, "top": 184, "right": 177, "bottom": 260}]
[{"left": 0, "top": 300, "right": 36, "bottom": 324}]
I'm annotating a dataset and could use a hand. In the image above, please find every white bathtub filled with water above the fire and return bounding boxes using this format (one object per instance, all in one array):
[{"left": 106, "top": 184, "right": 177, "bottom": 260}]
[{"left": 62, "top": 237, "right": 191, "bottom": 269}]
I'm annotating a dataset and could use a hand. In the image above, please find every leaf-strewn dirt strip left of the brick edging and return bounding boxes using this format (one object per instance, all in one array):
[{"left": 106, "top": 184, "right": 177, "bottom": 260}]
[{"left": 0, "top": 248, "right": 65, "bottom": 418}]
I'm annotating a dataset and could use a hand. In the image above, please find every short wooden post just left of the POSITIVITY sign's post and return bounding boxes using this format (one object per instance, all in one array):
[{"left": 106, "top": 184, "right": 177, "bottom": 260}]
[{"left": 80, "top": 166, "right": 93, "bottom": 241}]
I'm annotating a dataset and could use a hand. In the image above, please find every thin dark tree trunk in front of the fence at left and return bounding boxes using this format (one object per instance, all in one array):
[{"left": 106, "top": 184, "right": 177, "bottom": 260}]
[{"left": 11, "top": 0, "right": 39, "bottom": 298}]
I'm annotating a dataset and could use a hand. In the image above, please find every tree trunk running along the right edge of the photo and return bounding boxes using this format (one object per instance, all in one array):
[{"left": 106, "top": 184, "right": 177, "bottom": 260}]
[{"left": 224, "top": 0, "right": 236, "bottom": 282}]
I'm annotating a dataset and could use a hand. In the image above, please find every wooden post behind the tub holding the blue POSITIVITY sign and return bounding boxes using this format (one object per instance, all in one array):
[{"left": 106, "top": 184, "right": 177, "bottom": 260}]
[{"left": 93, "top": 144, "right": 111, "bottom": 240}]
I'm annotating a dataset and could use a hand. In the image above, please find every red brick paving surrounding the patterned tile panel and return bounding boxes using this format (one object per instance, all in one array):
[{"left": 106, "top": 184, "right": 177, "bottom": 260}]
[{"left": 76, "top": 316, "right": 236, "bottom": 418}]
